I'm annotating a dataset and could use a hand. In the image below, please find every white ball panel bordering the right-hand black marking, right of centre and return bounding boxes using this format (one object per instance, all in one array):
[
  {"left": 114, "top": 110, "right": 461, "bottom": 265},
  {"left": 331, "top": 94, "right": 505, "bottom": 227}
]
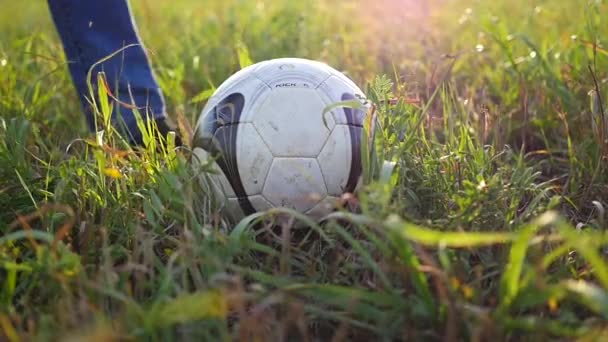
[{"left": 317, "top": 125, "right": 352, "bottom": 196}]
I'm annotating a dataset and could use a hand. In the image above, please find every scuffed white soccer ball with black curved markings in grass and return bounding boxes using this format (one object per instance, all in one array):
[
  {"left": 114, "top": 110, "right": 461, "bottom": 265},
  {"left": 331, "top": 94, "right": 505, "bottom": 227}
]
[{"left": 192, "top": 58, "right": 368, "bottom": 220}]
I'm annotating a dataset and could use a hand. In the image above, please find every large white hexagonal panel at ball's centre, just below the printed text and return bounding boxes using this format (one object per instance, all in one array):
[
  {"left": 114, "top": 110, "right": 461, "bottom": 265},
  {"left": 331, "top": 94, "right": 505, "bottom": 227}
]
[{"left": 253, "top": 88, "right": 334, "bottom": 158}]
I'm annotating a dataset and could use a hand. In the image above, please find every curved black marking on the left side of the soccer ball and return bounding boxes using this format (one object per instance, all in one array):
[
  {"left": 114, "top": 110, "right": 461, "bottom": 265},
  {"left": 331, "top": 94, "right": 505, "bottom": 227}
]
[{"left": 192, "top": 93, "right": 255, "bottom": 215}]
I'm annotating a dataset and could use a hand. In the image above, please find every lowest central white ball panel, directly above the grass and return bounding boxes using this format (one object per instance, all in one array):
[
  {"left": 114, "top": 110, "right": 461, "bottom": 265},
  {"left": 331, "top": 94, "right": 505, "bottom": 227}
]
[{"left": 262, "top": 158, "right": 327, "bottom": 212}]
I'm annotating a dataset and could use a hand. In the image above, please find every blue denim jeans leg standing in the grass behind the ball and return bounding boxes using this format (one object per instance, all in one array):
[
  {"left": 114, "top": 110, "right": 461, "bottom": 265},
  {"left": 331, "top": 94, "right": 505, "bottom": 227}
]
[{"left": 48, "top": 0, "right": 165, "bottom": 144}]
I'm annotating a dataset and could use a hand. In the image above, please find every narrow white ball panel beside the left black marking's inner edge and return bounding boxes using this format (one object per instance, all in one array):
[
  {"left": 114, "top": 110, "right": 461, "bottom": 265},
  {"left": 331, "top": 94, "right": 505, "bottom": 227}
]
[{"left": 236, "top": 123, "right": 273, "bottom": 196}]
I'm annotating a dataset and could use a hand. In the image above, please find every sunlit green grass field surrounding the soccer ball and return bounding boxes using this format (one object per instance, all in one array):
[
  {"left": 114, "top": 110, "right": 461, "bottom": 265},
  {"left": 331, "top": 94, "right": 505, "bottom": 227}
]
[{"left": 0, "top": 0, "right": 608, "bottom": 341}]
